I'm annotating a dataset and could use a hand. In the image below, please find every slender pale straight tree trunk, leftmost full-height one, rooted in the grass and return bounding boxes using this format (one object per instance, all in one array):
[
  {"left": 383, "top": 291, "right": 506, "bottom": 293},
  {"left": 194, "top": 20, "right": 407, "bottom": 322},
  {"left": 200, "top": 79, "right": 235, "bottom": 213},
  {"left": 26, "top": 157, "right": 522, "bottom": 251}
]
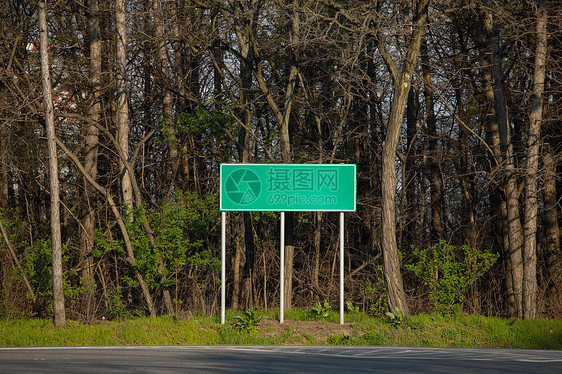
[{"left": 38, "top": 0, "right": 66, "bottom": 327}]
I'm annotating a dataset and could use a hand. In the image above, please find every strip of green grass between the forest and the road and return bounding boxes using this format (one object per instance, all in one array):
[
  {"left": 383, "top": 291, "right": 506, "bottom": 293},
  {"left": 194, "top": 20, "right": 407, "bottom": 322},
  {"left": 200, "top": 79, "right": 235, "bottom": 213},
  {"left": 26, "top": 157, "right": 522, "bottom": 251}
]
[{"left": 0, "top": 309, "right": 562, "bottom": 350}]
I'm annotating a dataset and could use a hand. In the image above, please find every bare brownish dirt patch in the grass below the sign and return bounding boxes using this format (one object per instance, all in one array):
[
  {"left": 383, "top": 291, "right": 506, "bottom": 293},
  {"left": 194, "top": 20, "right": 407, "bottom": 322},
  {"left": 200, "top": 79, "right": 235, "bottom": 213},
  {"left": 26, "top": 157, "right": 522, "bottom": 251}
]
[{"left": 258, "top": 319, "right": 360, "bottom": 344}]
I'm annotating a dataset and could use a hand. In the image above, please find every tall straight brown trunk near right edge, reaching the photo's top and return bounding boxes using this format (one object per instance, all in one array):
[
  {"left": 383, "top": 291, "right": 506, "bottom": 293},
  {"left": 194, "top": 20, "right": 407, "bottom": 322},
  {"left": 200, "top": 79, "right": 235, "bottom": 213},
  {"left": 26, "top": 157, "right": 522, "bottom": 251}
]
[{"left": 523, "top": 0, "right": 547, "bottom": 319}]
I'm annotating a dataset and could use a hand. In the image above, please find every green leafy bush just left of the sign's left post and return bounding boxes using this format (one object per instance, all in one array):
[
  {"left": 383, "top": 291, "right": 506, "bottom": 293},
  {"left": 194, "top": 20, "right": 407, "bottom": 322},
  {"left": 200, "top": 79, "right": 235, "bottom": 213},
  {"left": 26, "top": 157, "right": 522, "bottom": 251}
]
[{"left": 94, "top": 193, "right": 220, "bottom": 289}]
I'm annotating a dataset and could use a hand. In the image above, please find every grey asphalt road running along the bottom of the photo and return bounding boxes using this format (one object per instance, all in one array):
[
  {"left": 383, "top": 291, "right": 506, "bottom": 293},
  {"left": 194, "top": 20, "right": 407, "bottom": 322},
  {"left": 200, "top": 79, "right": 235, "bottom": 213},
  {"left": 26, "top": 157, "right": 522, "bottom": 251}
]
[{"left": 0, "top": 346, "right": 562, "bottom": 374}]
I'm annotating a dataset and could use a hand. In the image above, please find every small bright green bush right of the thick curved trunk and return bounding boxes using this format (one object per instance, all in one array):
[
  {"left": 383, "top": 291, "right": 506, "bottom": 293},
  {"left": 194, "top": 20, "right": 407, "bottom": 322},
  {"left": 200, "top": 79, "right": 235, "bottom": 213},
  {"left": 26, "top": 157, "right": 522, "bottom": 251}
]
[{"left": 405, "top": 241, "right": 499, "bottom": 314}]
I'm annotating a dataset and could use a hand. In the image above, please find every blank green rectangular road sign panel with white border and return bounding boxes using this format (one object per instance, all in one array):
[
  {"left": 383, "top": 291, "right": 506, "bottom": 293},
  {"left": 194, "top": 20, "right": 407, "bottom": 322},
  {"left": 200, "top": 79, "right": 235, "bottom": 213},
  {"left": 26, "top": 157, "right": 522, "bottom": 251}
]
[{"left": 220, "top": 164, "right": 357, "bottom": 212}]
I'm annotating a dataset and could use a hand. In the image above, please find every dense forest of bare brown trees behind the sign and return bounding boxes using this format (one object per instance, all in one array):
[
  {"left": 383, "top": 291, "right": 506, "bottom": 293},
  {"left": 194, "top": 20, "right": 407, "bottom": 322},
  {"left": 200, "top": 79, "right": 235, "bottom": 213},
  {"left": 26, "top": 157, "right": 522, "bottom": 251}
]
[{"left": 0, "top": 0, "right": 562, "bottom": 325}]
